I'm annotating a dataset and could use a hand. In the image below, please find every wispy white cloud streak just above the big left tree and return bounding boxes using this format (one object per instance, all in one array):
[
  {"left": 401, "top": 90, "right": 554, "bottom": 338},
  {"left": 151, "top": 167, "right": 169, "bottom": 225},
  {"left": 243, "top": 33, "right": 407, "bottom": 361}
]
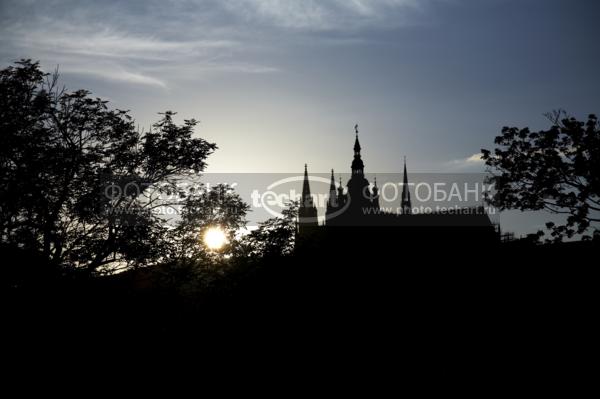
[{"left": 0, "top": 18, "right": 277, "bottom": 88}]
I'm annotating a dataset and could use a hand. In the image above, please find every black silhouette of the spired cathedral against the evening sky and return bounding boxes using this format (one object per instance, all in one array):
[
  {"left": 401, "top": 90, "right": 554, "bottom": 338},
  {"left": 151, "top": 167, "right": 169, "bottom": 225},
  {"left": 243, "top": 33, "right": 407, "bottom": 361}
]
[{"left": 298, "top": 125, "right": 499, "bottom": 250}]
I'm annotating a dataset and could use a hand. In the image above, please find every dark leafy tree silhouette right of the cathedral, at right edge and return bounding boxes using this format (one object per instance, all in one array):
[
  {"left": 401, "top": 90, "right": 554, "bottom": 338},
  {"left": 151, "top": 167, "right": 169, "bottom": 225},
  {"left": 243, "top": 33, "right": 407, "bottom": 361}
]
[{"left": 481, "top": 111, "right": 600, "bottom": 240}]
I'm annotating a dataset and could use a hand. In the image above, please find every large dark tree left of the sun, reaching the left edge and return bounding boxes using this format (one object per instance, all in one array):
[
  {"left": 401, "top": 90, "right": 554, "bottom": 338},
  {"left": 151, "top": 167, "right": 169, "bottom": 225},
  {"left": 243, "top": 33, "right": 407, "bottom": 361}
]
[{"left": 0, "top": 60, "right": 216, "bottom": 273}]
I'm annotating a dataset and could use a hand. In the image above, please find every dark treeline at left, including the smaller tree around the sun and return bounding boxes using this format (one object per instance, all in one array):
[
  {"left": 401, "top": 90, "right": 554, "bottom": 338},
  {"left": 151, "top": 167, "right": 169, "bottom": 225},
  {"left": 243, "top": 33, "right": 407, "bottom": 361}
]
[{"left": 0, "top": 60, "right": 293, "bottom": 285}]
